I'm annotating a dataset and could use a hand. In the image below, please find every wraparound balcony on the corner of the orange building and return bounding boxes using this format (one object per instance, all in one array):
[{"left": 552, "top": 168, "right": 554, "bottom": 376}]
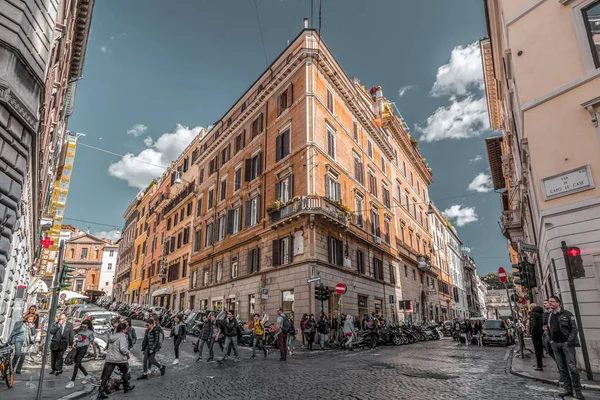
[{"left": 267, "top": 196, "right": 350, "bottom": 229}]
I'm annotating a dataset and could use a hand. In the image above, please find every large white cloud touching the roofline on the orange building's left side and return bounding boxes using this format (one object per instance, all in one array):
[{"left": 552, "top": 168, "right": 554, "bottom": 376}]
[{"left": 108, "top": 124, "right": 206, "bottom": 189}]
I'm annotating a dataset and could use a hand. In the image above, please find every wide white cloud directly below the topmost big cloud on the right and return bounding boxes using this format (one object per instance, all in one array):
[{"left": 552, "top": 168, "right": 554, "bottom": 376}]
[{"left": 416, "top": 96, "right": 489, "bottom": 142}]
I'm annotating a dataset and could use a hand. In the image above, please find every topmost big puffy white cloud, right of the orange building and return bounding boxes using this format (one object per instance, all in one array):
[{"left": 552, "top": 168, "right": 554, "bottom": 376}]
[{"left": 431, "top": 42, "right": 484, "bottom": 97}]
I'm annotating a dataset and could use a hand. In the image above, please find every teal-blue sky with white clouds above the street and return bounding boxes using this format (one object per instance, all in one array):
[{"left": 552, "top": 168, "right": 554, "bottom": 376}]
[{"left": 65, "top": 0, "right": 510, "bottom": 274}]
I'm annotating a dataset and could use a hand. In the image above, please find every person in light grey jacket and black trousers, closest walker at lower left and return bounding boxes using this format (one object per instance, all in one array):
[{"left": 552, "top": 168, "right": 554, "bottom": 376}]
[{"left": 98, "top": 323, "right": 135, "bottom": 399}]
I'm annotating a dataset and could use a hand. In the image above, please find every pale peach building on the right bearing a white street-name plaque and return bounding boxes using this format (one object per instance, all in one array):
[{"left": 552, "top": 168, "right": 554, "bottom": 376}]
[{"left": 481, "top": 0, "right": 600, "bottom": 372}]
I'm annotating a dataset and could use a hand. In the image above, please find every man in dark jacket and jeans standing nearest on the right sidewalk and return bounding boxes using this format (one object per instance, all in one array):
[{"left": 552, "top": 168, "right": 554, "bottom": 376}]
[{"left": 548, "top": 296, "right": 584, "bottom": 399}]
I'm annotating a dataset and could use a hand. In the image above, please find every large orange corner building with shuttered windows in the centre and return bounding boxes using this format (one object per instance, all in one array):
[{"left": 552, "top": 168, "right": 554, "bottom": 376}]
[{"left": 185, "top": 29, "right": 434, "bottom": 319}]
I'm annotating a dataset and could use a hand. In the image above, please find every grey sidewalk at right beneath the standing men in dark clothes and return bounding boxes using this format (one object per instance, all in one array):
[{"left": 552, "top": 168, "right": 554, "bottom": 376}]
[{"left": 510, "top": 338, "right": 600, "bottom": 391}]
